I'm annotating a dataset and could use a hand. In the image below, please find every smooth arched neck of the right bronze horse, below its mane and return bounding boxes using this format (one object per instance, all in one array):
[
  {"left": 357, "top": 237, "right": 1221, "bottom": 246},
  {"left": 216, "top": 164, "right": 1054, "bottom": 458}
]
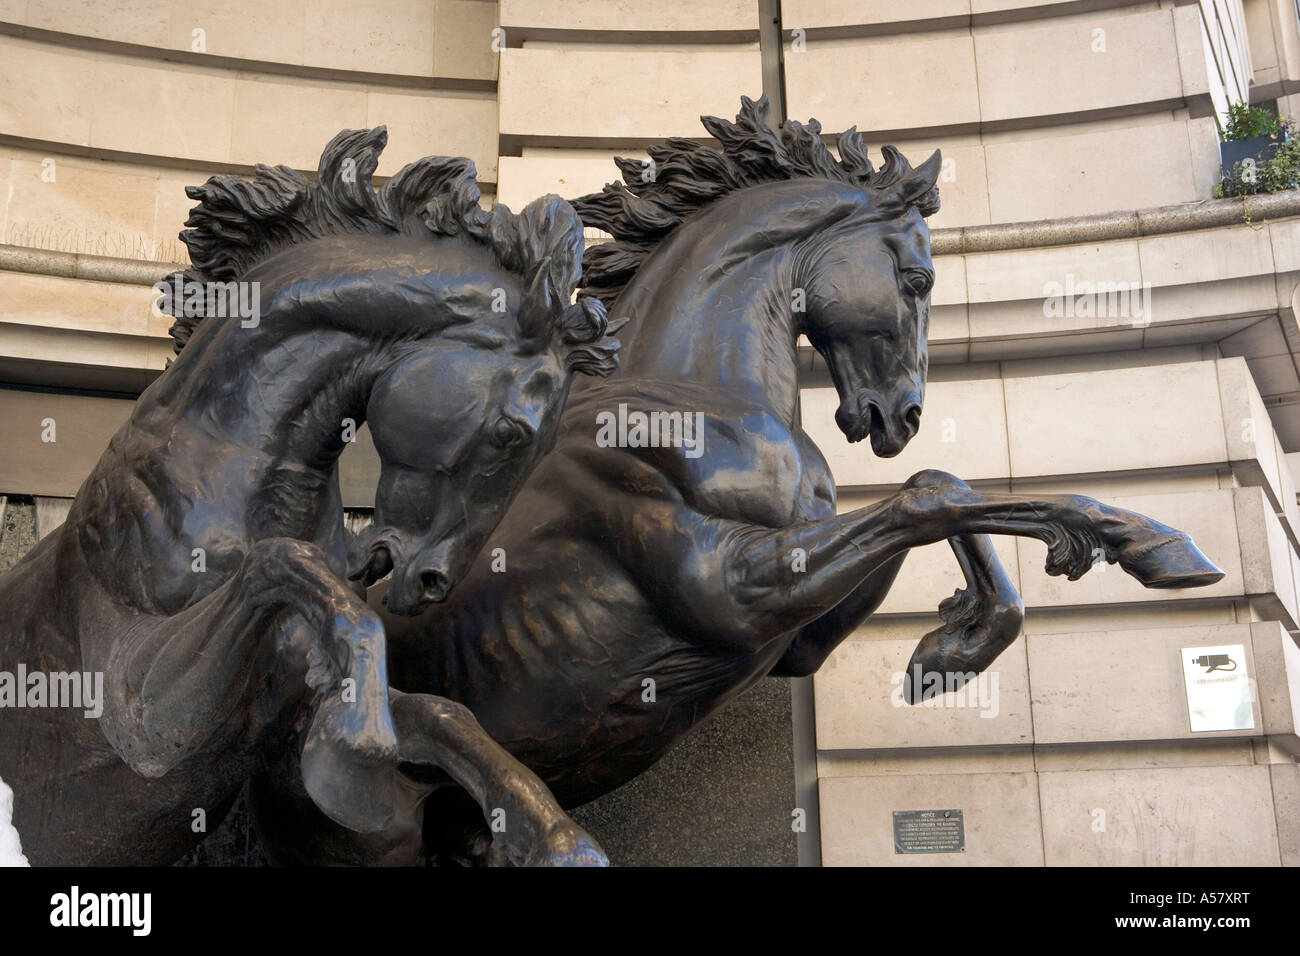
[{"left": 611, "top": 191, "right": 806, "bottom": 423}]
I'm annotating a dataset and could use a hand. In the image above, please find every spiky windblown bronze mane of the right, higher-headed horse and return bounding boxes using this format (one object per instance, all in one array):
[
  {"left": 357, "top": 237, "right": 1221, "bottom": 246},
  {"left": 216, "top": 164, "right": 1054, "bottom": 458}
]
[{"left": 571, "top": 94, "right": 939, "bottom": 306}]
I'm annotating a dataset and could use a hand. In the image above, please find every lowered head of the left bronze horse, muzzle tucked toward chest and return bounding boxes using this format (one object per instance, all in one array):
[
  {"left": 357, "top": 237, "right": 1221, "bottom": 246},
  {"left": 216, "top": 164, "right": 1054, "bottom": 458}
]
[{"left": 361, "top": 265, "right": 606, "bottom": 614}]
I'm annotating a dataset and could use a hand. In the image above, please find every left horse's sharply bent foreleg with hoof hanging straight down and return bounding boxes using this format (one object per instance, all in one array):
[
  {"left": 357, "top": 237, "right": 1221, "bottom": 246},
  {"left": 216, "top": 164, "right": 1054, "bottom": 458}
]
[{"left": 87, "top": 538, "right": 397, "bottom": 830}]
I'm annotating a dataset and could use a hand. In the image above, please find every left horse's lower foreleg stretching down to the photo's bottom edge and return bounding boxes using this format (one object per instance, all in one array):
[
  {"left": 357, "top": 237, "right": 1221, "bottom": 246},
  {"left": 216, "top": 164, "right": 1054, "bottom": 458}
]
[{"left": 391, "top": 691, "right": 608, "bottom": 866}]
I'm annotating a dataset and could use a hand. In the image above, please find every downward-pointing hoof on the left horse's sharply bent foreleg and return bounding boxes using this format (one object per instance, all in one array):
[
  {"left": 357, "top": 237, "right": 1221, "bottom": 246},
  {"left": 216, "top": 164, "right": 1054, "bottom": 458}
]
[{"left": 302, "top": 706, "right": 397, "bottom": 834}]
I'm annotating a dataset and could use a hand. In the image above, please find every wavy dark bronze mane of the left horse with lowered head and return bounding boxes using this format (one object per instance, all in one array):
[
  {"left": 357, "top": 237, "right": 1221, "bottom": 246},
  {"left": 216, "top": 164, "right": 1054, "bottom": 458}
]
[{"left": 161, "top": 126, "right": 606, "bottom": 364}]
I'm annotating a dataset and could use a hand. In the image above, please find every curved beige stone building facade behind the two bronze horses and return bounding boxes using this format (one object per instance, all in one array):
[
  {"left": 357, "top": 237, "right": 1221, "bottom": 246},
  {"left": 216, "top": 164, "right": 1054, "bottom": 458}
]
[{"left": 0, "top": 0, "right": 1300, "bottom": 865}]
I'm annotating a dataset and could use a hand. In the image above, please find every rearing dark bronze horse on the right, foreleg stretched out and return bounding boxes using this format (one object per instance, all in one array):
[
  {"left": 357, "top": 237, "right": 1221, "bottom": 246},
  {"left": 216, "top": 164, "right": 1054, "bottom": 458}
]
[{"left": 248, "top": 99, "right": 1222, "bottom": 861}]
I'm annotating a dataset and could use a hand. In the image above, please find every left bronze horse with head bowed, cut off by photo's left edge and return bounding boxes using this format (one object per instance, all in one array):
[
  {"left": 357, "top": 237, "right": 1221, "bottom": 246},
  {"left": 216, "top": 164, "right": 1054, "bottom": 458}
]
[{"left": 0, "top": 127, "right": 618, "bottom": 865}]
